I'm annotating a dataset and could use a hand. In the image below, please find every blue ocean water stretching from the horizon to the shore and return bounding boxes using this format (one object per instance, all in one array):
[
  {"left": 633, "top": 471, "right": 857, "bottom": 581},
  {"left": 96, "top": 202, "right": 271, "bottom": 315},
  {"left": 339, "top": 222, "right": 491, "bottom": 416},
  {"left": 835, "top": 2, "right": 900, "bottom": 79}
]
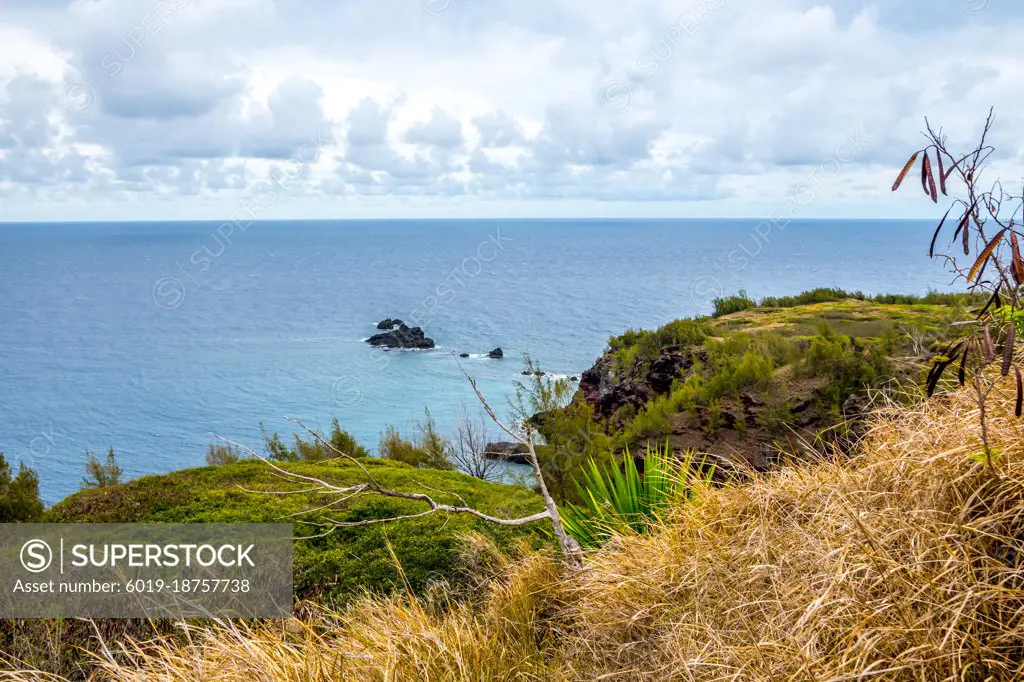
[{"left": 0, "top": 219, "right": 949, "bottom": 503}]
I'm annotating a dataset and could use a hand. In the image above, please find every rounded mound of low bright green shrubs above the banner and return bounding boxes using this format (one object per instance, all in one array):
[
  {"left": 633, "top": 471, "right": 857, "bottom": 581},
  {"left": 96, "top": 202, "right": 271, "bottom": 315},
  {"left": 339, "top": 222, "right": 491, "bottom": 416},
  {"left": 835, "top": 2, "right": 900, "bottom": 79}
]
[{"left": 45, "top": 458, "right": 544, "bottom": 603}]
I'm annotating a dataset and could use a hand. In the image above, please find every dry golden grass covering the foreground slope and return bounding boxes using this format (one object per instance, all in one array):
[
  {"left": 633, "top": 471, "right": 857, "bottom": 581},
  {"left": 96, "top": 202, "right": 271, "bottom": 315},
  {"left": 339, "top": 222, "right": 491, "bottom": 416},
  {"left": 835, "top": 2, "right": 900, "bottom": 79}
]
[{"left": 8, "top": 385, "right": 1024, "bottom": 682}]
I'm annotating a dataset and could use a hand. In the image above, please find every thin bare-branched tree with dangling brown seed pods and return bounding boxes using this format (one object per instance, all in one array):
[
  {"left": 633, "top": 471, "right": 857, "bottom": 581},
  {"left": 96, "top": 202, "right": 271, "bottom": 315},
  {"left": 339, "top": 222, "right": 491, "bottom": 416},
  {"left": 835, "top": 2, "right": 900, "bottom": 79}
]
[{"left": 893, "top": 111, "right": 1024, "bottom": 468}]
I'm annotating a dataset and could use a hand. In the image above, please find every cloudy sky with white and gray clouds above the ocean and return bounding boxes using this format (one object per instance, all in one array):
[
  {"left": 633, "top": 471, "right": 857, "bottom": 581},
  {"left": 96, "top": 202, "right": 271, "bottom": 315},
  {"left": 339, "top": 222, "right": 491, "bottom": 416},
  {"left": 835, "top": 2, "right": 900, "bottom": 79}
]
[{"left": 0, "top": 0, "right": 1024, "bottom": 220}]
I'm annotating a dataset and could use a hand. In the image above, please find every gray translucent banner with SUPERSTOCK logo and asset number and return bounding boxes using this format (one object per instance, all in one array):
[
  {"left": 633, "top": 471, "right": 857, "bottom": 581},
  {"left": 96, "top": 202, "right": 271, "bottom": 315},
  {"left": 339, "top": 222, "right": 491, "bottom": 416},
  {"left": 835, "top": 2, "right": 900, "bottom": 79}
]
[{"left": 0, "top": 523, "right": 292, "bottom": 619}]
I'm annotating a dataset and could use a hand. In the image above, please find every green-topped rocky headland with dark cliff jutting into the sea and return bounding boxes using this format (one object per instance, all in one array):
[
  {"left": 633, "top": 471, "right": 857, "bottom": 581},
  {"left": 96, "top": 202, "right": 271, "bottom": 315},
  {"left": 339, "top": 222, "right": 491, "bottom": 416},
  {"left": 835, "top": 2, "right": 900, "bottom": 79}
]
[{"left": 575, "top": 289, "right": 977, "bottom": 469}]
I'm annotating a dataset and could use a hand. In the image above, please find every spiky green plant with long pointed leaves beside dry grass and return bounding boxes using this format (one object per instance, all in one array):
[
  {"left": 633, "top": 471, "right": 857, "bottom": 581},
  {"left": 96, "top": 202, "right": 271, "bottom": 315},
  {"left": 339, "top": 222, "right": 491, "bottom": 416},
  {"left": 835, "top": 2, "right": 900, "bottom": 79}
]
[{"left": 562, "top": 443, "right": 715, "bottom": 548}]
